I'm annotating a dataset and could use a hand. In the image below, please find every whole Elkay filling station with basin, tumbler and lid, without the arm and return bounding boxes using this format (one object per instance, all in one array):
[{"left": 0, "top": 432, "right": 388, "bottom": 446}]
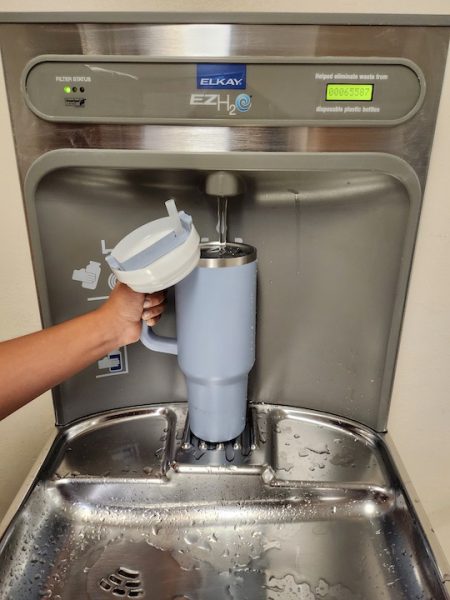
[{"left": 0, "top": 15, "right": 449, "bottom": 600}]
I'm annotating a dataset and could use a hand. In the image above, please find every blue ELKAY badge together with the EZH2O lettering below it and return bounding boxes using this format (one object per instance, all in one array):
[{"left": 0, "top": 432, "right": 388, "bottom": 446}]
[{"left": 190, "top": 63, "right": 252, "bottom": 116}]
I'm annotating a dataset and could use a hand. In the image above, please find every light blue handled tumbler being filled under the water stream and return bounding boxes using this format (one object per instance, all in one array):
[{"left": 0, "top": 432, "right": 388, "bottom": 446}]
[{"left": 141, "top": 242, "right": 257, "bottom": 443}]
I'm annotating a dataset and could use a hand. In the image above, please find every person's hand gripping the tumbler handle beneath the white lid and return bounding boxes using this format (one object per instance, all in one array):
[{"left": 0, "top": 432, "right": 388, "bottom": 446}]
[{"left": 97, "top": 283, "right": 166, "bottom": 346}]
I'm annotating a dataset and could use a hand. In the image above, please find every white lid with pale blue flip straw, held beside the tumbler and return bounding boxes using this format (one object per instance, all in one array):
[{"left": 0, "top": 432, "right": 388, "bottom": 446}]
[{"left": 106, "top": 200, "right": 200, "bottom": 293}]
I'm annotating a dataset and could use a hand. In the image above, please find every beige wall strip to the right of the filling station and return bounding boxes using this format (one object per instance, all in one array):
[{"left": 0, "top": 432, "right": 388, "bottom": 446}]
[{"left": 389, "top": 48, "right": 450, "bottom": 558}]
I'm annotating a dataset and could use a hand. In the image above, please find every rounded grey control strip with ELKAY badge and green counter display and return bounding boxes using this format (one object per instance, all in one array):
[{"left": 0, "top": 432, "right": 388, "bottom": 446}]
[{"left": 23, "top": 56, "right": 425, "bottom": 126}]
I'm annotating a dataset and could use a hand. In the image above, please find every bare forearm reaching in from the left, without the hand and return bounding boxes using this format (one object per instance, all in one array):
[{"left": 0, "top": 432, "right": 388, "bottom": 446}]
[{"left": 0, "top": 310, "right": 121, "bottom": 419}]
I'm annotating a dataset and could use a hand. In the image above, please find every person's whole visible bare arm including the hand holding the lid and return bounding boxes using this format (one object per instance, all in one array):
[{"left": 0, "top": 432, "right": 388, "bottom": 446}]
[{"left": 0, "top": 284, "right": 165, "bottom": 419}]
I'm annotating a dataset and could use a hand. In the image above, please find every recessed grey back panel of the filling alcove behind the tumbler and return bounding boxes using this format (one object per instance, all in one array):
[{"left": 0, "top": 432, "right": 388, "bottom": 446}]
[{"left": 27, "top": 152, "right": 419, "bottom": 429}]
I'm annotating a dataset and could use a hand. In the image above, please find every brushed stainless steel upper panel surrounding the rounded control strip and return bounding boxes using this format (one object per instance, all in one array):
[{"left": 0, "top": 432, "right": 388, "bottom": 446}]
[{"left": 0, "top": 24, "right": 448, "bottom": 183}]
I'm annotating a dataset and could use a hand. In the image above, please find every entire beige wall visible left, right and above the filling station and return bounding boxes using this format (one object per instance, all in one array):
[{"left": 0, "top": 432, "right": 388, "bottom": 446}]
[{"left": 0, "top": 0, "right": 450, "bottom": 568}]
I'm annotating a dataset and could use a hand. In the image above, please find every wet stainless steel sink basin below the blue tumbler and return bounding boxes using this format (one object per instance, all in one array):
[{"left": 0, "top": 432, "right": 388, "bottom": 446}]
[{"left": 0, "top": 404, "right": 449, "bottom": 600}]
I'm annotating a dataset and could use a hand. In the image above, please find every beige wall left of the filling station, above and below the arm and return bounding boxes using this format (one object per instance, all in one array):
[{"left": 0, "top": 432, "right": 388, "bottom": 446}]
[{"left": 0, "top": 51, "right": 53, "bottom": 520}]
